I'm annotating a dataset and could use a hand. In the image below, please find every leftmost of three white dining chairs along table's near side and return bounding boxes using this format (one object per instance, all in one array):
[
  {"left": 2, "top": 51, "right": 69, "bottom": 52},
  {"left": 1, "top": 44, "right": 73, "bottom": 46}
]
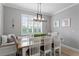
[{"left": 29, "top": 37, "right": 41, "bottom": 56}]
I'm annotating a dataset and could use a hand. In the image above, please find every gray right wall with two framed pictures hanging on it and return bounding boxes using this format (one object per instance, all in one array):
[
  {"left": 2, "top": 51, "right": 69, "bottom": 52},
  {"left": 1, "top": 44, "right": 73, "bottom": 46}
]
[{"left": 51, "top": 4, "right": 79, "bottom": 49}]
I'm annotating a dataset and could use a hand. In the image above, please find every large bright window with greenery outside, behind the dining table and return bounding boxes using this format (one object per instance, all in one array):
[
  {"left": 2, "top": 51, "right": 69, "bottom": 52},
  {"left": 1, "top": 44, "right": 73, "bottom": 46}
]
[{"left": 21, "top": 14, "right": 42, "bottom": 35}]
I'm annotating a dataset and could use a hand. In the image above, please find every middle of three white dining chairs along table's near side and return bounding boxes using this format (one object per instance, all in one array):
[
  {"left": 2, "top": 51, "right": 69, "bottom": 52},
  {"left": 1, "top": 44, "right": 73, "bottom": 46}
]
[{"left": 44, "top": 36, "right": 52, "bottom": 56}]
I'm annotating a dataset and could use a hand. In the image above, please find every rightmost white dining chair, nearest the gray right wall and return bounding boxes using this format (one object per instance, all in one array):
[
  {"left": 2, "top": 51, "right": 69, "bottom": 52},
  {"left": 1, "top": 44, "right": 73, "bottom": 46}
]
[{"left": 54, "top": 33, "right": 61, "bottom": 56}]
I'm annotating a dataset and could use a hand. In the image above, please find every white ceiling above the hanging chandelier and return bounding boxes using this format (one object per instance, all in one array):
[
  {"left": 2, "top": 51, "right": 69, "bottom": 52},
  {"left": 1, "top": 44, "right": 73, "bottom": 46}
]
[{"left": 4, "top": 3, "right": 74, "bottom": 15}]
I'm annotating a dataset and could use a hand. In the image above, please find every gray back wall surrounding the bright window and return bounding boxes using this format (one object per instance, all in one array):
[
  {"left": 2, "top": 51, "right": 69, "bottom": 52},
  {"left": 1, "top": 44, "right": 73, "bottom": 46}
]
[{"left": 3, "top": 6, "right": 51, "bottom": 35}]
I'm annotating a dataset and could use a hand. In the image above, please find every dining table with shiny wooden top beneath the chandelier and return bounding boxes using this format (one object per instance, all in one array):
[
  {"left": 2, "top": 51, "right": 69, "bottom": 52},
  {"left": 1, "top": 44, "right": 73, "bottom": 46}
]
[{"left": 17, "top": 36, "right": 53, "bottom": 56}]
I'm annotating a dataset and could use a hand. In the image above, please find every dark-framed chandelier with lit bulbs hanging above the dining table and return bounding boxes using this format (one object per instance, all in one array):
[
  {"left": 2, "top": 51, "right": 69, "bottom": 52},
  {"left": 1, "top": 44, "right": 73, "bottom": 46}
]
[{"left": 33, "top": 3, "right": 46, "bottom": 22}]
